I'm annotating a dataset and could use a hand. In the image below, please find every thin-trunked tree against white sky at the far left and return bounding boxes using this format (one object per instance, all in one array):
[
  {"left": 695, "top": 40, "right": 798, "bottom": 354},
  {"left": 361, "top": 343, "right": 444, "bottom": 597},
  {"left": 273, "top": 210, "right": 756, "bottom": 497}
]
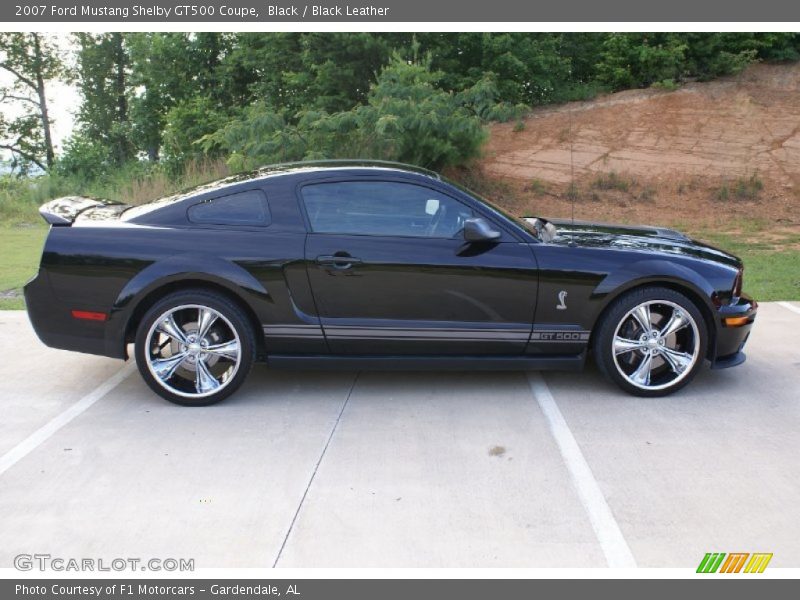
[{"left": 0, "top": 33, "right": 63, "bottom": 170}]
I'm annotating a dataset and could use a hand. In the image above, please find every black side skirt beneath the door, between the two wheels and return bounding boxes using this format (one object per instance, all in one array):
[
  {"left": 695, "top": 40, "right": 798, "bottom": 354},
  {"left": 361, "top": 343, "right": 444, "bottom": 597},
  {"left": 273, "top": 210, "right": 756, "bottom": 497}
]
[{"left": 267, "top": 352, "right": 586, "bottom": 371}]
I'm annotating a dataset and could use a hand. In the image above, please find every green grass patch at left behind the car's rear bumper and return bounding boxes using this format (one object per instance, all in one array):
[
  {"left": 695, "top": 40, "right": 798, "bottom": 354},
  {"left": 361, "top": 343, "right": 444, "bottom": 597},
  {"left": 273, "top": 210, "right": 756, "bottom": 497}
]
[{"left": 0, "top": 226, "right": 47, "bottom": 310}]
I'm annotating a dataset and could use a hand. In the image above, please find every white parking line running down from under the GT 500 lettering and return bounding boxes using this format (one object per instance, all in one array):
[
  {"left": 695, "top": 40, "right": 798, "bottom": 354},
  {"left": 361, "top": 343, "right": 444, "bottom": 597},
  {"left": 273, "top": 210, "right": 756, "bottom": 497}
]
[{"left": 528, "top": 372, "right": 636, "bottom": 568}]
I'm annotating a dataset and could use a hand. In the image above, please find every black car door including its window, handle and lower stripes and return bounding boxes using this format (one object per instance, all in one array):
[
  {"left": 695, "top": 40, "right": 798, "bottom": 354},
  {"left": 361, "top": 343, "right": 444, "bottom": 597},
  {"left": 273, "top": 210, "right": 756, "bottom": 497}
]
[{"left": 300, "top": 180, "right": 537, "bottom": 355}]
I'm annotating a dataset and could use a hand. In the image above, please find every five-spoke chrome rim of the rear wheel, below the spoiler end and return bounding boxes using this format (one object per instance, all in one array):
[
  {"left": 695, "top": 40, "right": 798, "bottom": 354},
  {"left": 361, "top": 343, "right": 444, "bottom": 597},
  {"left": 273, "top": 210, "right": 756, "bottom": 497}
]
[{"left": 145, "top": 304, "right": 242, "bottom": 399}]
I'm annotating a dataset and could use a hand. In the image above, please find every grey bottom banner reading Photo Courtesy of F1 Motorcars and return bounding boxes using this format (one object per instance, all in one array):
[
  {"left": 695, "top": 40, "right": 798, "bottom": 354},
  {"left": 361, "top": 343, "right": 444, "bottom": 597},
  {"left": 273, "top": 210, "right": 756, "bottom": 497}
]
[{"left": 0, "top": 575, "right": 797, "bottom": 600}]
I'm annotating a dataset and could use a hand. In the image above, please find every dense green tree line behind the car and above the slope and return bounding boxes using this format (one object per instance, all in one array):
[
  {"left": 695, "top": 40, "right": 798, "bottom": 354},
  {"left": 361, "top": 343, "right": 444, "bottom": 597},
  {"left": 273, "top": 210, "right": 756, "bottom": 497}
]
[{"left": 45, "top": 32, "right": 800, "bottom": 179}]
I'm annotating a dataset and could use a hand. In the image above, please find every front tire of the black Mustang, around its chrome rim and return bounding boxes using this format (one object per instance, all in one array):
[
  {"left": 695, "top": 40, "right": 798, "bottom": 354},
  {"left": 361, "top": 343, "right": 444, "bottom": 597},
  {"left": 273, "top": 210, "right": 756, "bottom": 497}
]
[{"left": 592, "top": 287, "right": 708, "bottom": 397}]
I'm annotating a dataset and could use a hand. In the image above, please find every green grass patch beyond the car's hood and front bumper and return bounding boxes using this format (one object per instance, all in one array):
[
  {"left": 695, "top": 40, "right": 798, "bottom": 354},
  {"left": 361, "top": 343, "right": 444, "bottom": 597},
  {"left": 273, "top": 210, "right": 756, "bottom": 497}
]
[{"left": 693, "top": 231, "right": 800, "bottom": 302}]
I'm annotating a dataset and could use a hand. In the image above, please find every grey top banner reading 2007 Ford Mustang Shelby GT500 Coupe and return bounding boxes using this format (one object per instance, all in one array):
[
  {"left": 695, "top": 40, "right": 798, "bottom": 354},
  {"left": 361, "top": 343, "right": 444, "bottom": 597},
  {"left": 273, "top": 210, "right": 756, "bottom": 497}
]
[{"left": 0, "top": 0, "right": 800, "bottom": 23}]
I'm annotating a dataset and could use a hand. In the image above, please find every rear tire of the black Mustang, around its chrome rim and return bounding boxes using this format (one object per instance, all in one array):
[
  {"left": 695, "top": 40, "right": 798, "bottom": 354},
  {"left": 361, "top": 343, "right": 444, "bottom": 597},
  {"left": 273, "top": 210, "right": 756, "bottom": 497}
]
[{"left": 135, "top": 289, "right": 256, "bottom": 406}]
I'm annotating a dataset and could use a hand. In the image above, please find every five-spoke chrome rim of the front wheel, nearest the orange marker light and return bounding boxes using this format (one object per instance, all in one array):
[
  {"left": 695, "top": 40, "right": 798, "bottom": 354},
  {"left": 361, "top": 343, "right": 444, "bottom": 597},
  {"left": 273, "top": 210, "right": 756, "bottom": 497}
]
[{"left": 611, "top": 300, "right": 701, "bottom": 391}]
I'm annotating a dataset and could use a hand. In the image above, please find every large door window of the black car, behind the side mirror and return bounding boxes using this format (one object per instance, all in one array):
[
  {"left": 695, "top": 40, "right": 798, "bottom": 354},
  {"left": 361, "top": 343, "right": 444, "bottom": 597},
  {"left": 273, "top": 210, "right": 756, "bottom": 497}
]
[{"left": 301, "top": 181, "right": 473, "bottom": 238}]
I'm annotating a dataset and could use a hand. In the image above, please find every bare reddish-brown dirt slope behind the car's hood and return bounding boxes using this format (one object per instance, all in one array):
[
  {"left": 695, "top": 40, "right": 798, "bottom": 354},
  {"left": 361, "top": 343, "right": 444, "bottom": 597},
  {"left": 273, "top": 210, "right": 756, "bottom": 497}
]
[{"left": 480, "top": 64, "right": 800, "bottom": 229}]
